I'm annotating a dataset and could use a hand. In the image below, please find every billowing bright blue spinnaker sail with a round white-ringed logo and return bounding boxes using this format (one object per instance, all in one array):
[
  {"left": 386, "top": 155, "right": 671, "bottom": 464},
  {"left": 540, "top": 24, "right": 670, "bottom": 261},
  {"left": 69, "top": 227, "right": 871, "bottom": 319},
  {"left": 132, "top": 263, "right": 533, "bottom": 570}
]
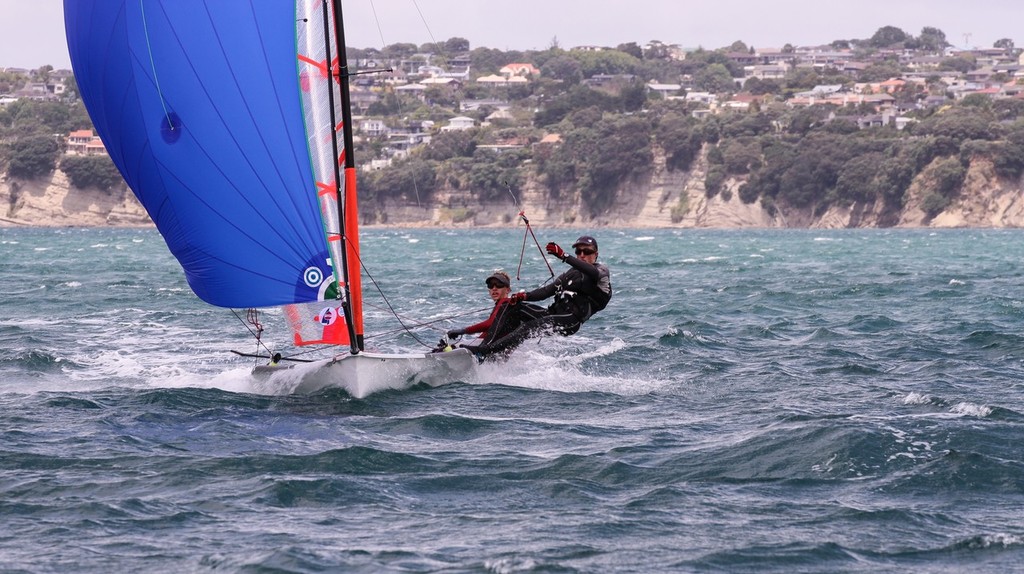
[{"left": 65, "top": 0, "right": 332, "bottom": 307}]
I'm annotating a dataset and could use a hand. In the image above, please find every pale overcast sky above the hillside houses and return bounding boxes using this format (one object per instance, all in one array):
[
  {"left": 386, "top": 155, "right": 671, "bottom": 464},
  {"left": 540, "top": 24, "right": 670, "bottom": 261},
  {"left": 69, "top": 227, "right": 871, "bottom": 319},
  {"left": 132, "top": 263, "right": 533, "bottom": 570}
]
[{"left": 0, "top": 0, "right": 1024, "bottom": 69}]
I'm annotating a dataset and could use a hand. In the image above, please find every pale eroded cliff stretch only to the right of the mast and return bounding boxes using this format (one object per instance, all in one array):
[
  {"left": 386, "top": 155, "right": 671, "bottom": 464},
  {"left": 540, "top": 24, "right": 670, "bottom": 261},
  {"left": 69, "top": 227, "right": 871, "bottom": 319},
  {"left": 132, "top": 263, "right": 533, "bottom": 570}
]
[{"left": 364, "top": 145, "right": 1024, "bottom": 229}]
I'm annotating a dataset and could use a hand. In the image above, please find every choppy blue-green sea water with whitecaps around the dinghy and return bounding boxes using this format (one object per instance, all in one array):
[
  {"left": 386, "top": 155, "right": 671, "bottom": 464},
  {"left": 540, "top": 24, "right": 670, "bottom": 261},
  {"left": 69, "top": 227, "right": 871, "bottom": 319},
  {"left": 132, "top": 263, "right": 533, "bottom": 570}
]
[{"left": 0, "top": 226, "right": 1024, "bottom": 573}]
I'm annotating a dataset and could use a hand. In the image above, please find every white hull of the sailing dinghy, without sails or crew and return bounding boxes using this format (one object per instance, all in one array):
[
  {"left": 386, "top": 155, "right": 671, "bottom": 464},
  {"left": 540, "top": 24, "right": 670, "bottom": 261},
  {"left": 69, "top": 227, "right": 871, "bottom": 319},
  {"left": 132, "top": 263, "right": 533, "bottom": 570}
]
[{"left": 253, "top": 349, "right": 477, "bottom": 399}]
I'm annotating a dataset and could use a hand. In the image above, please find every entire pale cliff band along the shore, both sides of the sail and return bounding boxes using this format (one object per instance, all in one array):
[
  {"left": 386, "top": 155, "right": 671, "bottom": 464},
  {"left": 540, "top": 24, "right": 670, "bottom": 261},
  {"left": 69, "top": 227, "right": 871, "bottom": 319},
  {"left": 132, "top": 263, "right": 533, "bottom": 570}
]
[{"left": 0, "top": 153, "right": 1024, "bottom": 228}]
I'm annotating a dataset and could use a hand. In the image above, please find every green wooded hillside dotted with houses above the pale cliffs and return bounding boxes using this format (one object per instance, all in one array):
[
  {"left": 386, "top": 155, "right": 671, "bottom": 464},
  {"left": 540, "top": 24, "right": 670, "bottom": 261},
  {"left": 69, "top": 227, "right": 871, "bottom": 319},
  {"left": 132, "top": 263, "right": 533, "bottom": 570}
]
[{"left": 0, "top": 27, "right": 1024, "bottom": 226}]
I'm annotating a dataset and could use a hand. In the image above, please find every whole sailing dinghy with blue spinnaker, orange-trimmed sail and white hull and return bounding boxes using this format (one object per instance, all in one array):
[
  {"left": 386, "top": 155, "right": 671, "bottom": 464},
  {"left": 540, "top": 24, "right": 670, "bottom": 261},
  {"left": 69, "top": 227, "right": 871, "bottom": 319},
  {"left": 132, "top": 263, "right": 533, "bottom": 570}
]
[{"left": 65, "top": 0, "right": 476, "bottom": 398}]
